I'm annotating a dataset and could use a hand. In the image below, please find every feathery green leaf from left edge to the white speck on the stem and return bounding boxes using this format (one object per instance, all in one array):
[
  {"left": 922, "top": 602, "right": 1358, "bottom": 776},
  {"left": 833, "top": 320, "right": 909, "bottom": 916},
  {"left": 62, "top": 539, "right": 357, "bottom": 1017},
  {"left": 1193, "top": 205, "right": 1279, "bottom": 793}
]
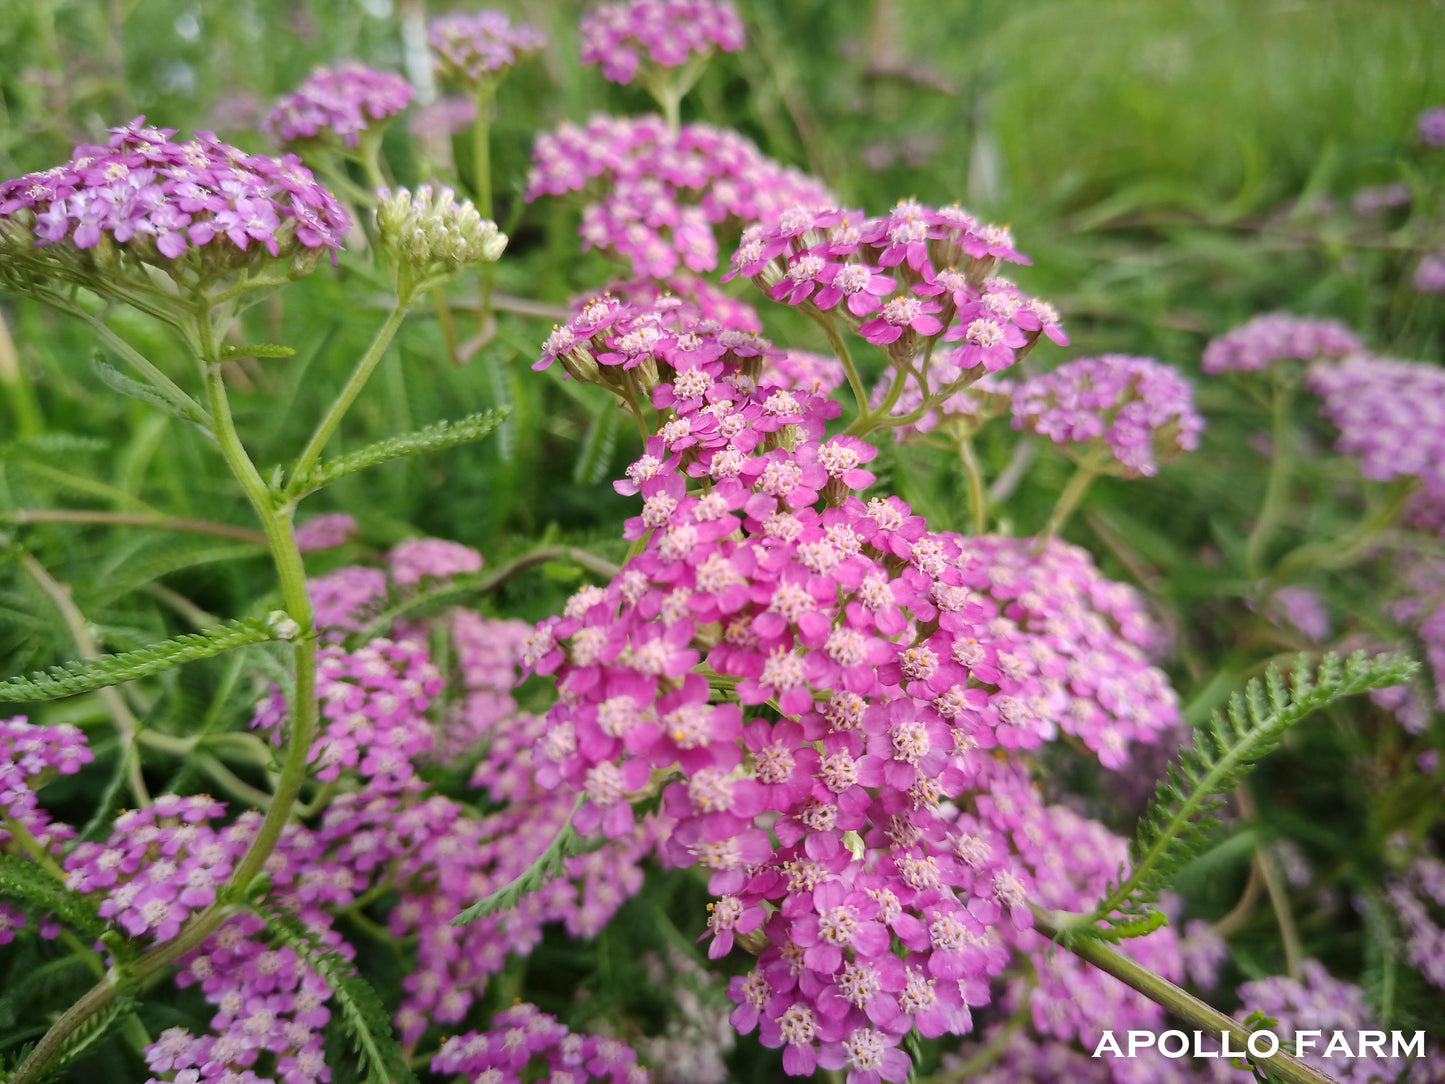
[{"left": 0, "top": 613, "right": 290, "bottom": 702}]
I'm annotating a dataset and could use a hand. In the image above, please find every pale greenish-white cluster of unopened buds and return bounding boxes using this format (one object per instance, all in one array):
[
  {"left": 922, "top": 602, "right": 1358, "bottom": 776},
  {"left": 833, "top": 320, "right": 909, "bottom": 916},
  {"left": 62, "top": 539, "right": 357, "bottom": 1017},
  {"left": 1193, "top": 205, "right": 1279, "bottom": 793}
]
[{"left": 376, "top": 185, "right": 507, "bottom": 301}]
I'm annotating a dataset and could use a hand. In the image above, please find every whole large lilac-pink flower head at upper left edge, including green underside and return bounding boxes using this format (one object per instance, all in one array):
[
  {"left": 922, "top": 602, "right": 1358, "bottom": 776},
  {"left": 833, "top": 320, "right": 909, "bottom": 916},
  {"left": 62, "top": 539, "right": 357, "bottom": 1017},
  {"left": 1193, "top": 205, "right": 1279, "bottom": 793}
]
[{"left": 0, "top": 117, "right": 350, "bottom": 299}]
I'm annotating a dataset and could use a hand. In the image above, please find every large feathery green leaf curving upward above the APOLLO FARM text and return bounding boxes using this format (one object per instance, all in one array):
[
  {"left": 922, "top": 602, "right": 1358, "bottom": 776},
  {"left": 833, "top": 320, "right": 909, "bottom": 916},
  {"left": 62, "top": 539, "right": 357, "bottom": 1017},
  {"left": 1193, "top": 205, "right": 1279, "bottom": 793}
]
[{"left": 1071, "top": 652, "right": 1418, "bottom": 939}]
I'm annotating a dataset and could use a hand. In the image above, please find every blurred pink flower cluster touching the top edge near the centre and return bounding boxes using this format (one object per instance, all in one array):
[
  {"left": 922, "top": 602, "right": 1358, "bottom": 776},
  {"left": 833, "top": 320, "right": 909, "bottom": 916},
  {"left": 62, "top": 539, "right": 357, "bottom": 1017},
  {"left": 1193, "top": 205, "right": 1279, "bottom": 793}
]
[{"left": 581, "top": 0, "right": 744, "bottom": 82}]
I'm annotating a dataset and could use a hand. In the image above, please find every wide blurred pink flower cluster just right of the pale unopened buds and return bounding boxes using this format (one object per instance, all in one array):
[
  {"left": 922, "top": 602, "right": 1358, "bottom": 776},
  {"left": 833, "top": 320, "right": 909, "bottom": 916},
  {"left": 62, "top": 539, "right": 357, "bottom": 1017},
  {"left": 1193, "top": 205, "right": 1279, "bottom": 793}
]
[{"left": 526, "top": 114, "right": 834, "bottom": 279}]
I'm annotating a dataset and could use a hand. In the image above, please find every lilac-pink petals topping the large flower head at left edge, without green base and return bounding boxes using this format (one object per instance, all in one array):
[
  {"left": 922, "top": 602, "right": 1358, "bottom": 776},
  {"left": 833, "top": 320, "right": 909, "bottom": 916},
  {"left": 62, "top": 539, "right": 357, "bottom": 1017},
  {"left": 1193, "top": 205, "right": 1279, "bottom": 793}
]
[{"left": 0, "top": 117, "right": 350, "bottom": 262}]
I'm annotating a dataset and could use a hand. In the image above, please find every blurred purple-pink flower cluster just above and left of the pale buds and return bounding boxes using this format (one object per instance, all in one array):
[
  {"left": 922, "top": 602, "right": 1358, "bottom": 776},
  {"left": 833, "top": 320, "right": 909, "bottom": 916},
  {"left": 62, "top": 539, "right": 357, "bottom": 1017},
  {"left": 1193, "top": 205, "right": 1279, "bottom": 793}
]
[{"left": 262, "top": 62, "right": 412, "bottom": 147}]
